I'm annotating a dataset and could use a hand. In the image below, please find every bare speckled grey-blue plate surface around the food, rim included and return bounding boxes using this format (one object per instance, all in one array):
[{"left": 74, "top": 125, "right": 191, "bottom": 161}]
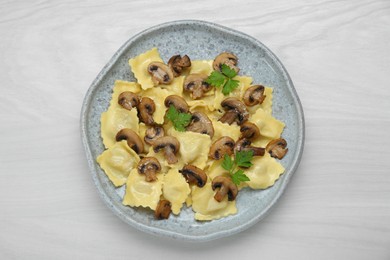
[{"left": 81, "top": 20, "right": 304, "bottom": 241}]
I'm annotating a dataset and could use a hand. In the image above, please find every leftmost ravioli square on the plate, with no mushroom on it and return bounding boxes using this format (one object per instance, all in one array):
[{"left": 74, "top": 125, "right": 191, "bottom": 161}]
[{"left": 97, "top": 140, "right": 140, "bottom": 187}]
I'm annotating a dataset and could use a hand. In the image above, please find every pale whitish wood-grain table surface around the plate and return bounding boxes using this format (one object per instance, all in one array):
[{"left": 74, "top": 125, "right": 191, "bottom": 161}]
[{"left": 0, "top": 0, "right": 390, "bottom": 259}]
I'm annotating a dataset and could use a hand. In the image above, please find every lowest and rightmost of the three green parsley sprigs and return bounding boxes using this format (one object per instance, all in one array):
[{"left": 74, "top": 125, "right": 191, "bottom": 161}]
[{"left": 222, "top": 150, "right": 253, "bottom": 185}]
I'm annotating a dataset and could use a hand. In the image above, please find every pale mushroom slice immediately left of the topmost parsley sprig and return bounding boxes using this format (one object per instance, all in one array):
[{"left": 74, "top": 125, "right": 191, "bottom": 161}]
[{"left": 183, "top": 73, "right": 211, "bottom": 99}]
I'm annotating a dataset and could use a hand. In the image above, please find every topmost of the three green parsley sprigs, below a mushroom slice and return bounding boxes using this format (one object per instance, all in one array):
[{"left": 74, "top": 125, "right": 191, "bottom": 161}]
[{"left": 206, "top": 64, "right": 240, "bottom": 96}]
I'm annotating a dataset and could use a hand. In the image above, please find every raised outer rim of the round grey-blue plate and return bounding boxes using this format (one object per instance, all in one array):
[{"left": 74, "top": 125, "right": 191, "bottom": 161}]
[{"left": 80, "top": 19, "right": 305, "bottom": 242}]
